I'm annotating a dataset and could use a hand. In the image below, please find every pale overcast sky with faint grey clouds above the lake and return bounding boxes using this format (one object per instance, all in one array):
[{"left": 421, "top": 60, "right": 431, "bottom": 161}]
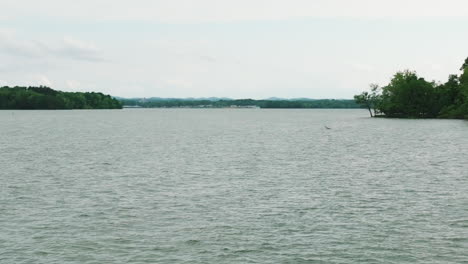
[{"left": 0, "top": 0, "right": 468, "bottom": 98}]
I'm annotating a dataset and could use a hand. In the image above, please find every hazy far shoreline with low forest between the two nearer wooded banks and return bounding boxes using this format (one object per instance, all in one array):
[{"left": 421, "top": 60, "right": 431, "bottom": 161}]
[{"left": 120, "top": 98, "right": 361, "bottom": 108}]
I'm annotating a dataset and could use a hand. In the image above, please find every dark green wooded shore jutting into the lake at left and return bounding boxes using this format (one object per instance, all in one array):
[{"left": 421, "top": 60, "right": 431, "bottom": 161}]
[{"left": 0, "top": 86, "right": 122, "bottom": 109}]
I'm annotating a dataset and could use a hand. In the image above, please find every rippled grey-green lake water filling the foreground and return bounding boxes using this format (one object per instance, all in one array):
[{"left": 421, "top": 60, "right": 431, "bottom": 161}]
[{"left": 0, "top": 109, "right": 468, "bottom": 264}]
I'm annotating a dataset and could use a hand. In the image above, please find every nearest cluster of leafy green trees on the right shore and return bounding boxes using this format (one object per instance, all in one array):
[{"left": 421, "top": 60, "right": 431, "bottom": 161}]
[{"left": 354, "top": 58, "right": 468, "bottom": 119}]
